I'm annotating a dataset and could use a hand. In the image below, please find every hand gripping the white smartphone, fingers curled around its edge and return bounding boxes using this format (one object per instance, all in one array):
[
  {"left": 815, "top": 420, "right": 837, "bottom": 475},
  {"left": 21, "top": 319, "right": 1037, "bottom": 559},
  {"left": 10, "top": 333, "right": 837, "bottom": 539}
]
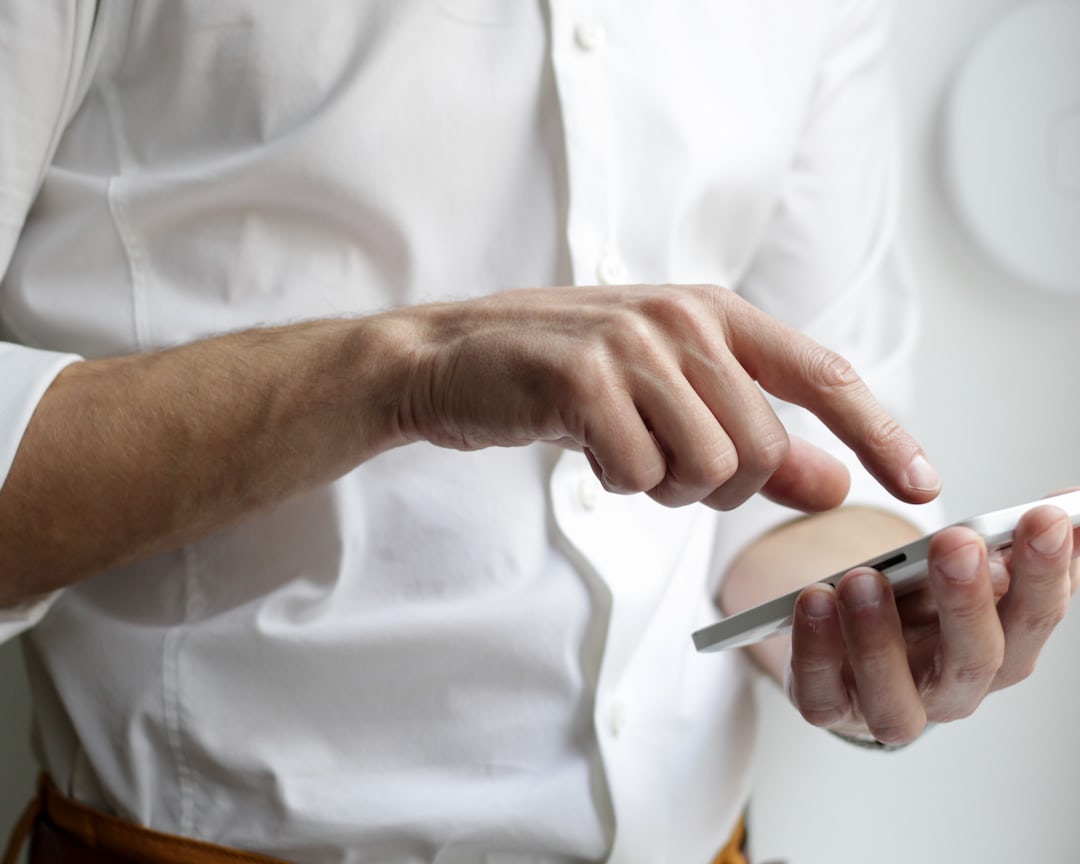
[{"left": 786, "top": 498, "right": 1080, "bottom": 744}]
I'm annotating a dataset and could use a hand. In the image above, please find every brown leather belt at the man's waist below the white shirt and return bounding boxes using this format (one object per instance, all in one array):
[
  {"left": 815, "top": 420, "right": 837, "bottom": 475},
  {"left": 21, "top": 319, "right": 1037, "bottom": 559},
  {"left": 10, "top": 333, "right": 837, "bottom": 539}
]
[{"left": 2, "top": 777, "right": 747, "bottom": 864}]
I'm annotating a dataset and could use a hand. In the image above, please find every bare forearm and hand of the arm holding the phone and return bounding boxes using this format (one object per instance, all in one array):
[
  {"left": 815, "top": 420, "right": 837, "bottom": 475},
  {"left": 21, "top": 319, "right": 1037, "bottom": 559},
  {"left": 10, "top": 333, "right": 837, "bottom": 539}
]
[{"left": 721, "top": 507, "right": 1080, "bottom": 744}]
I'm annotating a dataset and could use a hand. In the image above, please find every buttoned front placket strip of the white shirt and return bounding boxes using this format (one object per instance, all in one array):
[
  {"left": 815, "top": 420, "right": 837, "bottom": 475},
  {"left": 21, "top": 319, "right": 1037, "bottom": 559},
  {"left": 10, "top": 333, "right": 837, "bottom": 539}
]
[{"left": 550, "top": 0, "right": 664, "bottom": 862}]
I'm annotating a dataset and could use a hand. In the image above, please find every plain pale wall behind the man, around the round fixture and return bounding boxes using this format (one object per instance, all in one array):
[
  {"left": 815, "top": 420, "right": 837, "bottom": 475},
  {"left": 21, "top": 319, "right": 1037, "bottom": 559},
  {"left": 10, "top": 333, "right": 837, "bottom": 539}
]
[{"left": 0, "top": 0, "right": 1080, "bottom": 864}]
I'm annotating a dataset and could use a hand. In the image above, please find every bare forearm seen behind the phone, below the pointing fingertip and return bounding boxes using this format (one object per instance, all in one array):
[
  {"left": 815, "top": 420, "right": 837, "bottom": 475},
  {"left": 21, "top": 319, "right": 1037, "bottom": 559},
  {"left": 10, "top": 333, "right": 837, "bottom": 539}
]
[{"left": 720, "top": 507, "right": 919, "bottom": 683}]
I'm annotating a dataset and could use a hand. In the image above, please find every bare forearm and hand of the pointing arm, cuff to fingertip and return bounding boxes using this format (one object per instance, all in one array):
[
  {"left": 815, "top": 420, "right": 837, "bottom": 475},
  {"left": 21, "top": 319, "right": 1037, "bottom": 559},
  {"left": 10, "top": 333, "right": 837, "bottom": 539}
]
[{"left": 0, "top": 286, "right": 936, "bottom": 605}]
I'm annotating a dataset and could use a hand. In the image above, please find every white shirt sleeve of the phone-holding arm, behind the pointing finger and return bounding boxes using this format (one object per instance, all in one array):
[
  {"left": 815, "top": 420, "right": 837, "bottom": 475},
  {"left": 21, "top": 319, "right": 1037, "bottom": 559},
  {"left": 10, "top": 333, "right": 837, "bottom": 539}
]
[{"left": 715, "top": 0, "right": 941, "bottom": 587}]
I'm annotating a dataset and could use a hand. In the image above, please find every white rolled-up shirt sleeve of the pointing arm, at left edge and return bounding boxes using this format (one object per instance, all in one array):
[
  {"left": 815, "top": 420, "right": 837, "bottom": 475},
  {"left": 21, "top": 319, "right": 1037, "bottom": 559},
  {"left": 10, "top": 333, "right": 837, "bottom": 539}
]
[{"left": 0, "top": 0, "right": 96, "bottom": 640}]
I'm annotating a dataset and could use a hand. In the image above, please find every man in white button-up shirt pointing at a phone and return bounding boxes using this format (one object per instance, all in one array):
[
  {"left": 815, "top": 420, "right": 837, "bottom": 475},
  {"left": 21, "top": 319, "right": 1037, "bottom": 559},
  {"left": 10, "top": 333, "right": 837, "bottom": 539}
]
[{"left": 0, "top": 0, "right": 1071, "bottom": 864}]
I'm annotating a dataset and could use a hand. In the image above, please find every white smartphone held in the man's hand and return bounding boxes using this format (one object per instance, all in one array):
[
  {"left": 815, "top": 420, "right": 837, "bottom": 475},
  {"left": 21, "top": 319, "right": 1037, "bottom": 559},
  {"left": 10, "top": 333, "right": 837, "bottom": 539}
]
[{"left": 693, "top": 490, "right": 1080, "bottom": 651}]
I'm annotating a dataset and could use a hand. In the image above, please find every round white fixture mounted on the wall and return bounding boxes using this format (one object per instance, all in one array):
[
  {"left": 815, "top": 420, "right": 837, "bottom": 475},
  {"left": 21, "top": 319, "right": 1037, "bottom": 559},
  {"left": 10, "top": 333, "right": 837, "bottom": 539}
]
[{"left": 944, "top": 0, "right": 1080, "bottom": 295}]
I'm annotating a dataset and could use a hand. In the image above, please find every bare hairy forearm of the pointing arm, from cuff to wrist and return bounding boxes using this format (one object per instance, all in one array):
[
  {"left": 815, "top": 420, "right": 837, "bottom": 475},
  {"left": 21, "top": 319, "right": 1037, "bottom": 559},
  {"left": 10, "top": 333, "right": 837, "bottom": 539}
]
[{"left": 0, "top": 316, "right": 409, "bottom": 605}]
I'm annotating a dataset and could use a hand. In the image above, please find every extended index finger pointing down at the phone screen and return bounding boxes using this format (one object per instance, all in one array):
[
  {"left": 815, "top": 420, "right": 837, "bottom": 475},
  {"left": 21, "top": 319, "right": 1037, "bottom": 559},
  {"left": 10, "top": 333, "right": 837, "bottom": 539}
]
[{"left": 728, "top": 294, "right": 941, "bottom": 503}]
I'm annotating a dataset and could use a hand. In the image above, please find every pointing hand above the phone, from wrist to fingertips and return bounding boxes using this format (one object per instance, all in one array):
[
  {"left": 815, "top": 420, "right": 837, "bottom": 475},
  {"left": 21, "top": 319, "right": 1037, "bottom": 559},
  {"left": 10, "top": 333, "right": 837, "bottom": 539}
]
[{"left": 400, "top": 286, "right": 939, "bottom": 510}]
